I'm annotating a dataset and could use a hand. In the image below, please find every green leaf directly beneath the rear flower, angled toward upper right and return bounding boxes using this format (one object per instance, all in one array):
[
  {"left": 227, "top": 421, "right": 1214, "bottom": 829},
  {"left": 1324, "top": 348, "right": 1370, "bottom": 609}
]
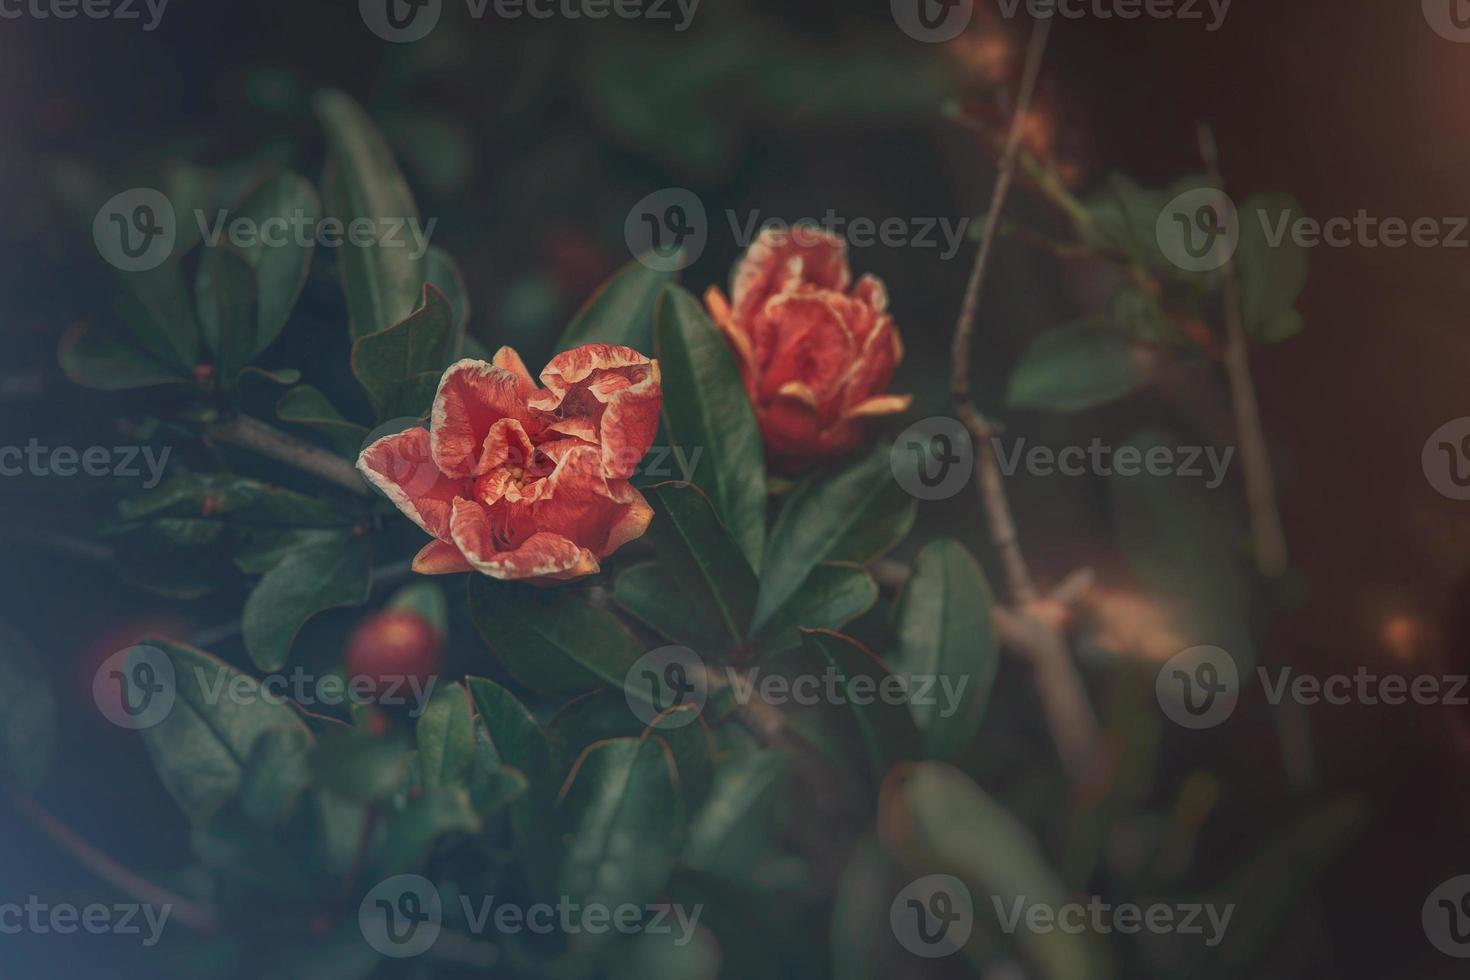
[{"left": 756, "top": 447, "right": 917, "bottom": 633}]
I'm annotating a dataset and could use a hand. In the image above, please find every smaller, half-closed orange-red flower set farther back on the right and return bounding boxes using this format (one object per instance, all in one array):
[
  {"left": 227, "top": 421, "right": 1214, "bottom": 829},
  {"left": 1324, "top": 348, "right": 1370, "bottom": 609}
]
[{"left": 704, "top": 226, "right": 911, "bottom": 472}]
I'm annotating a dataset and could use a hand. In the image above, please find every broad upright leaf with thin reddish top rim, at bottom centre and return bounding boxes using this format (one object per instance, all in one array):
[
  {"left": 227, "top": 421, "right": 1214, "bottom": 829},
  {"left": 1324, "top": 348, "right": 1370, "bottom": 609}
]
[{"left": 559, "top": 736, "right": 684, "bottom": 908}]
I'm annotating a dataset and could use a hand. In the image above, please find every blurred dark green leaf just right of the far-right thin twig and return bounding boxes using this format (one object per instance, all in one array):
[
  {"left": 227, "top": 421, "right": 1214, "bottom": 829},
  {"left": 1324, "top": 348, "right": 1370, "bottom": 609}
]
[{"left": 1235, "top": 194, "right": 1308, "bottom": 336}]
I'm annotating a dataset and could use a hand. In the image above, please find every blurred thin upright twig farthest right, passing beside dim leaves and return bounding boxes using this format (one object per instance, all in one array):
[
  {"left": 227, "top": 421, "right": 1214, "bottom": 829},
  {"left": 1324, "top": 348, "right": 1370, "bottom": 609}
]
[{"left": 1200, "top": 123, "right": 1286, "bottom": 577}]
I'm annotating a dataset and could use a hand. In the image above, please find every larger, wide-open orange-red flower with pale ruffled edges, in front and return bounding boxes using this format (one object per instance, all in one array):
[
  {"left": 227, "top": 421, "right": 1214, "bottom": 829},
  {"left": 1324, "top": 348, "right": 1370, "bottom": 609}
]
[{"left": 357, "top": 344, "right": 663, "bottom": 585}]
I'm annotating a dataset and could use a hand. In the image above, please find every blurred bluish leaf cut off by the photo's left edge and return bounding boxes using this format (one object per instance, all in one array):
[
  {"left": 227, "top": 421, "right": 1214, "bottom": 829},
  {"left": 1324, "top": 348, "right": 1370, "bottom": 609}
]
[{"left": 0, "top": 621, "right": 56, "bottom": 792}]
